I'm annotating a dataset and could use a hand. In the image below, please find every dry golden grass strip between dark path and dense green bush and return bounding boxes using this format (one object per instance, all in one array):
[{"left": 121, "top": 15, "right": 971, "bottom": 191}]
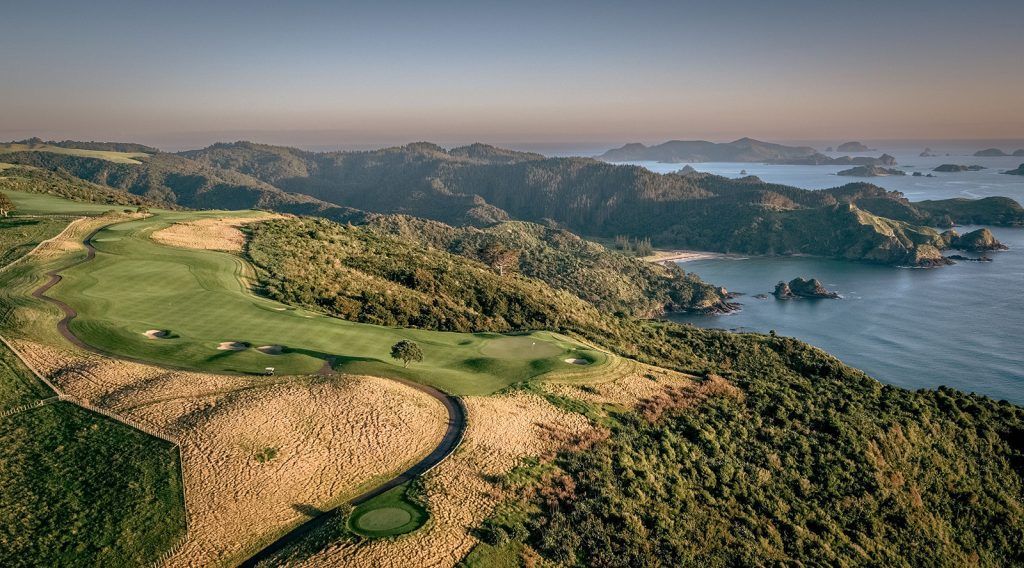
[{"left": 292, "top": 392, "right": 602, "bottom": 568}]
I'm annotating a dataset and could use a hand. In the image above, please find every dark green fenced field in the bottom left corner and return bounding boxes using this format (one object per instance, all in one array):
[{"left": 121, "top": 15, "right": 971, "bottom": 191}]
[{"left": 0, "top": 402, "right": 185, "bottom": 566}]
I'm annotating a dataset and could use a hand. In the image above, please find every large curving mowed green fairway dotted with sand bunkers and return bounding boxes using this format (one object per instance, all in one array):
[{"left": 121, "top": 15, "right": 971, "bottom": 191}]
[{"left": 49, "top": 211, "right": 605, "bottom": 394}]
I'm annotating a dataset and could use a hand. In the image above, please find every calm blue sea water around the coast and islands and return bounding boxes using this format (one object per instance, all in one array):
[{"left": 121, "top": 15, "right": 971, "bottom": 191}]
[{"left": 614, "top": 146, "right": 1024, "bottom": 404}]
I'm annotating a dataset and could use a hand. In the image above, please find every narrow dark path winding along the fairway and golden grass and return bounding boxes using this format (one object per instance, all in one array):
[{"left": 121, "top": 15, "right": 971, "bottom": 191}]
[{"left": 32, "top": 216, "right": 467, "bottom": 567}]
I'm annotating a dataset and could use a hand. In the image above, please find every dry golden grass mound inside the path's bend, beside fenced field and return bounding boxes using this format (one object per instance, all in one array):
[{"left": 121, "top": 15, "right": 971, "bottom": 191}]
[{"left": 9, "top": 341, "right": 447, "bottom": 566}]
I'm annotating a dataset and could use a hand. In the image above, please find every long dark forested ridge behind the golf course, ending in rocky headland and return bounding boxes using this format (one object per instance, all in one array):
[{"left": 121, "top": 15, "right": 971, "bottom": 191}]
[{"left": 4, "top": 142, "right": 1024, "bottom": 266}]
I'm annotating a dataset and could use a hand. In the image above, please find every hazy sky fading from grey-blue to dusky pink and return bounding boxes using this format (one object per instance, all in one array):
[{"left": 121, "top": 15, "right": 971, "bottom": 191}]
[{"left": 0, "top": 0, "right": 1024, "bottom": 147}]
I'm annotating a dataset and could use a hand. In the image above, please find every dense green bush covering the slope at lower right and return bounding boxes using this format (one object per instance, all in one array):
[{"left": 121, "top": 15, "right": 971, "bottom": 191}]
[{"left": 481, "top": 324, "right": 1024, "bottom": 567}]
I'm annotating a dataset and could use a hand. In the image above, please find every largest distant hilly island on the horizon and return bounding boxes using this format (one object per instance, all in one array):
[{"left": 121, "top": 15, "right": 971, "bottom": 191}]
[{"left": 597, "top": 138, "right": 816, "bottom": 164}]
